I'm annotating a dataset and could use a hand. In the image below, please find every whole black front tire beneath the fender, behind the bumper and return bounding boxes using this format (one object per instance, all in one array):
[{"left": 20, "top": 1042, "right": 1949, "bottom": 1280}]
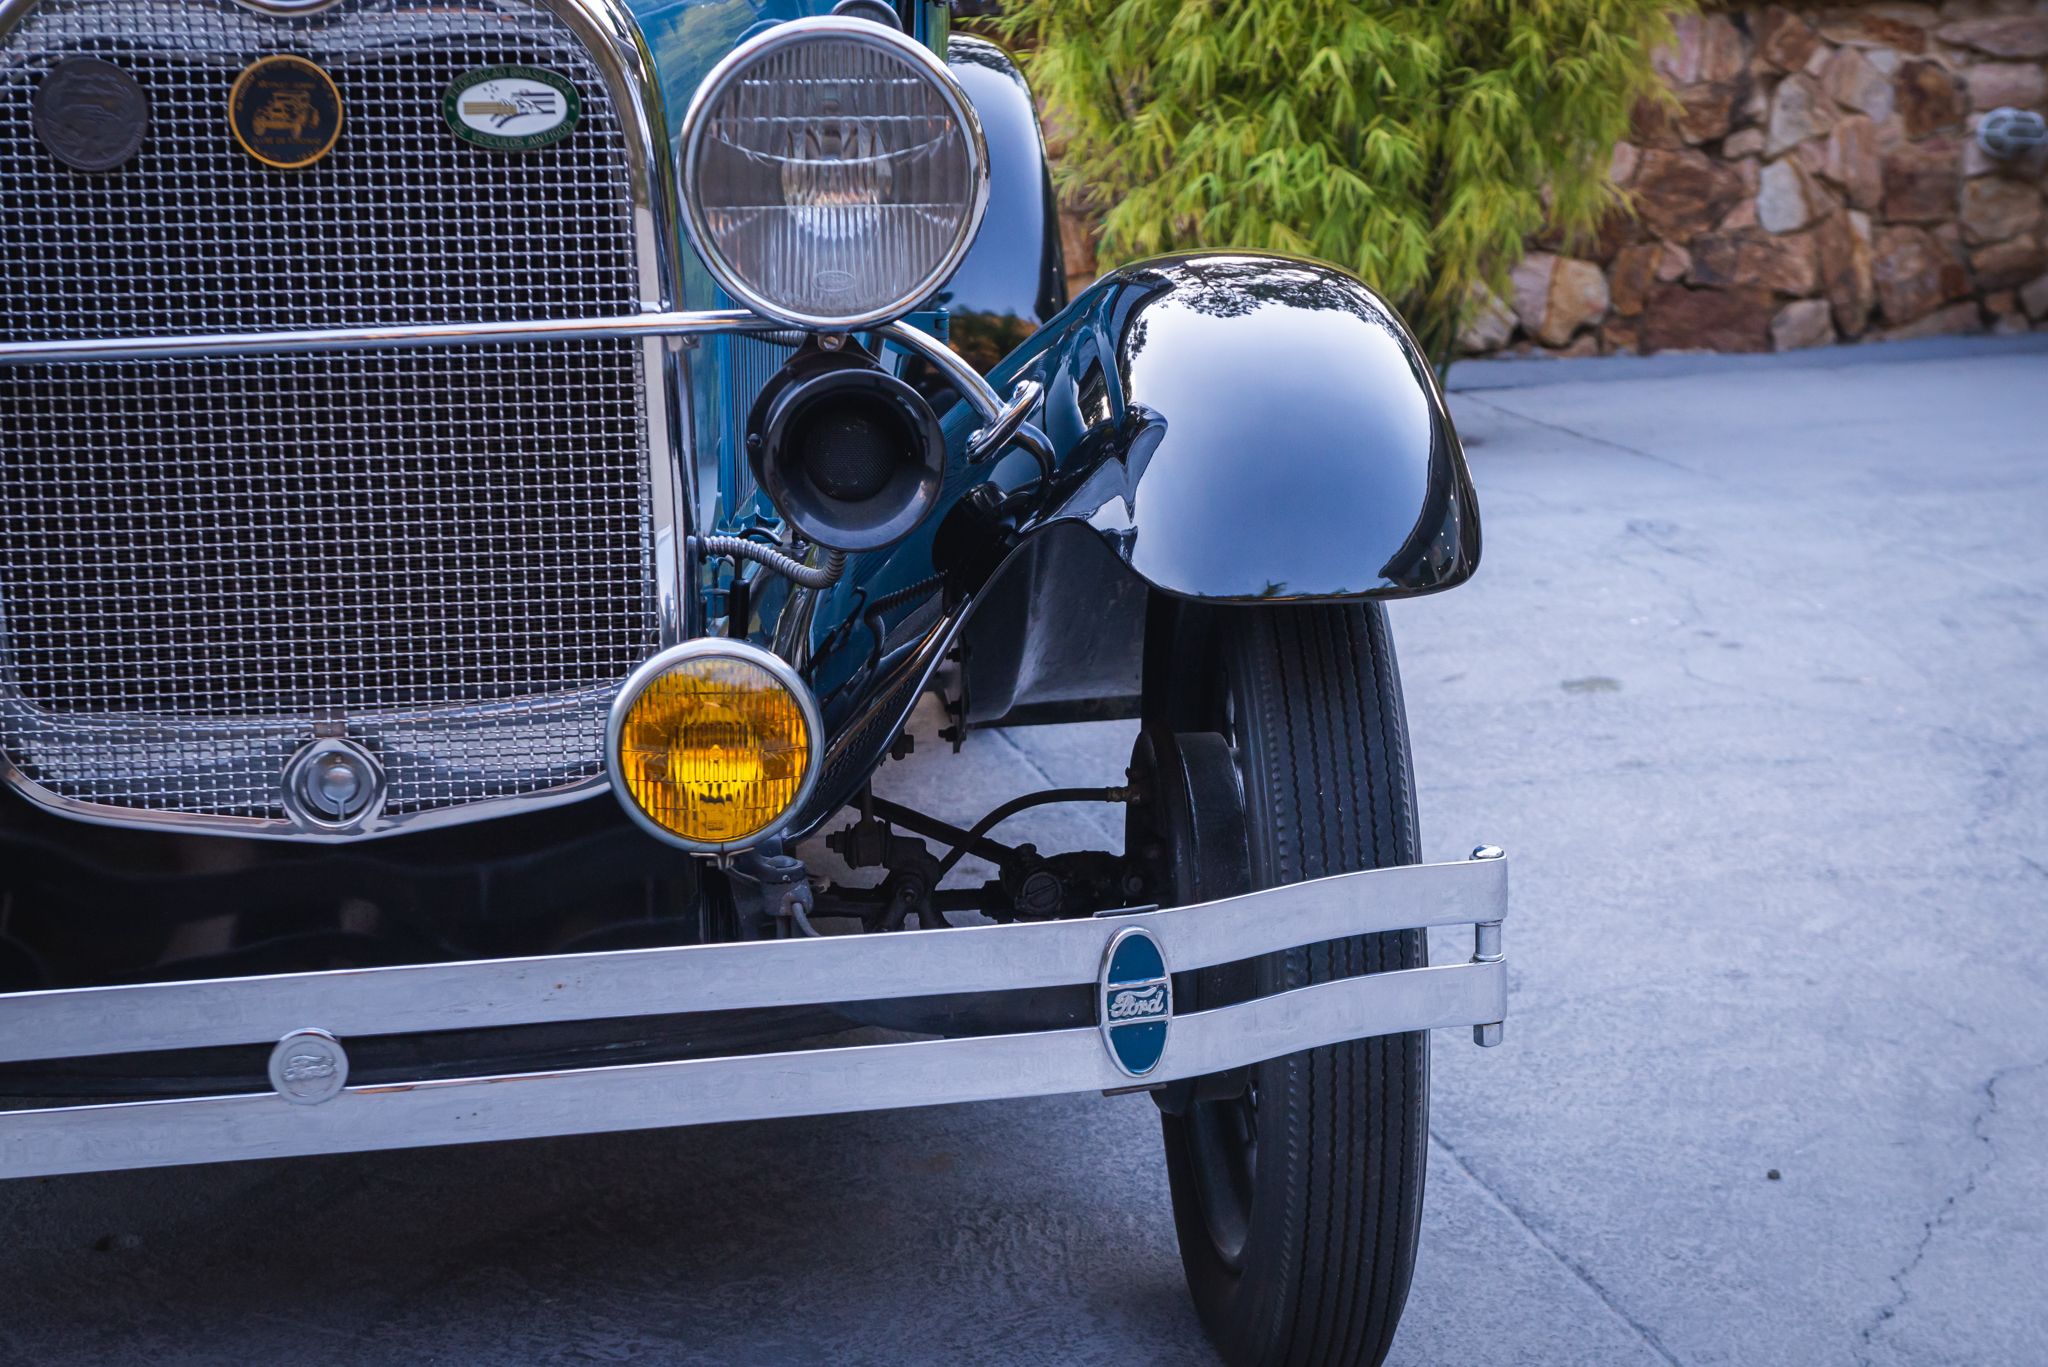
[{"left": 1147, "top": 600, "right": 1430, "bottom": 1367}]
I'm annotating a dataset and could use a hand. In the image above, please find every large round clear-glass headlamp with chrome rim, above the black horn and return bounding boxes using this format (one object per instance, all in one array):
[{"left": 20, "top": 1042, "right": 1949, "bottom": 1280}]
[{"left": 682, "top": 18, "right": 989, "bottom": 332}]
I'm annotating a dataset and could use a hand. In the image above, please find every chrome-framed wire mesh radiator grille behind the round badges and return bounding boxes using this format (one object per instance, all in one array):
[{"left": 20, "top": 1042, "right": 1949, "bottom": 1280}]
[{"left": 0, "top": 0, "right": 684, "bottom": 840}]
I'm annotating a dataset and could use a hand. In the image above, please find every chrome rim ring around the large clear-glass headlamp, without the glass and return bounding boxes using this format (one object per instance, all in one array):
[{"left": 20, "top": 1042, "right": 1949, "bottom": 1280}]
[{"left": 676, "top": 14, "right": 989, "bottom": 332}]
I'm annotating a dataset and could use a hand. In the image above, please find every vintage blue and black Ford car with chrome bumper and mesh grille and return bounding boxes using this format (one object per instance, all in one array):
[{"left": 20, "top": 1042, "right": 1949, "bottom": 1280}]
[{"left": 0, "top": 0, "right": 1507, "bottom": 1363}]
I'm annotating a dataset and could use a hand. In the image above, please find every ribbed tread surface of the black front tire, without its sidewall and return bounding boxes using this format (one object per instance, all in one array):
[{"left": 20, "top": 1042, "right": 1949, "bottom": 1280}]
[{"left": 1231, "top": 605, "right": 1427, "bottom": 1367}]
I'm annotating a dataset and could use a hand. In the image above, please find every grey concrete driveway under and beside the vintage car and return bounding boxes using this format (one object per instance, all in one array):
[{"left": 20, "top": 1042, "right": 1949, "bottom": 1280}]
[{"left": 0, "top": 348, "right": 2048, "bottom": 1367}]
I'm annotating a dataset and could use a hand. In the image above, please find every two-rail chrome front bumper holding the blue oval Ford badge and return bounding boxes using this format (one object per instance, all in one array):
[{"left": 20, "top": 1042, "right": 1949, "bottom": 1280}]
[{"left": 0, "top": 851, "right": 1507, "bottom": 1178}]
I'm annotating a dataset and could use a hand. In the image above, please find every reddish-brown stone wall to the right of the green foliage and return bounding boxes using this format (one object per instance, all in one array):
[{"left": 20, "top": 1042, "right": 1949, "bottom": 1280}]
[{"left": 1464, "top": 0, "right": 2048, "bottom": 357}]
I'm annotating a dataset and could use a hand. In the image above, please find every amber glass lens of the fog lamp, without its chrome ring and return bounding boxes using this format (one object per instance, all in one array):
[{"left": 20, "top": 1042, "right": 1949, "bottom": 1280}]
[{"left": 618, "top": 656, "right": 811, "bottom": 844}]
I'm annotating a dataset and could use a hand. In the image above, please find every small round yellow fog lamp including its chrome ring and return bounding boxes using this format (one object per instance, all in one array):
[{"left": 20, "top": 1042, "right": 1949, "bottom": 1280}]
[{"left": 604, "top": 639, "right": 823, "bottom": 855}]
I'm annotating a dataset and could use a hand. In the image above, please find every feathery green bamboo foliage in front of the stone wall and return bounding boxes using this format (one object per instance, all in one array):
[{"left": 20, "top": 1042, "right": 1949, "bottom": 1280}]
[{"left": 1001, "top": 0, "right": 1692, "bottom": 365}]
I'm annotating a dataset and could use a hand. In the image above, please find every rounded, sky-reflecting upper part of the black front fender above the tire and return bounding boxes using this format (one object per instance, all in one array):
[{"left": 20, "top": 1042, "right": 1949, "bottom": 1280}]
[{"left": 991, "top": 252, "right": 1479, "bottom": 603}]
